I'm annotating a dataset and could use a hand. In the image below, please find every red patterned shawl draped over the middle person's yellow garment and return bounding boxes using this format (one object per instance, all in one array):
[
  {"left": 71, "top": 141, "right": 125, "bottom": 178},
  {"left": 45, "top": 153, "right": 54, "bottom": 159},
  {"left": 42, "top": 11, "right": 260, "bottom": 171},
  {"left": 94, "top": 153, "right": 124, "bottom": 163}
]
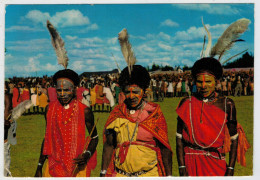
[{"left": 103, "top": 102, "right": 171, "bottom": 177}]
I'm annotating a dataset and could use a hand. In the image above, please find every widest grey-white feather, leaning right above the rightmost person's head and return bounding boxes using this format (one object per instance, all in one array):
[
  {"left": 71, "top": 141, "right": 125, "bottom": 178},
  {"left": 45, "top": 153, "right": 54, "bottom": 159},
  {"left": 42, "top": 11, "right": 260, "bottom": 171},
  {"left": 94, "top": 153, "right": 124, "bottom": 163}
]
[{"left": 210, "top": 18, "right": 251, "bottom": 60}]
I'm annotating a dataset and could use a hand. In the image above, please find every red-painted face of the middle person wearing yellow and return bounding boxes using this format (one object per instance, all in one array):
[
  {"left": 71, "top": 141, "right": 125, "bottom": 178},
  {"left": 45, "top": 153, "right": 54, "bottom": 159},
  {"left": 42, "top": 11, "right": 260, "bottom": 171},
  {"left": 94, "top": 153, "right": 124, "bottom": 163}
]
[{"left": 124, "top": 84, "right": 144, "bottom": 107}]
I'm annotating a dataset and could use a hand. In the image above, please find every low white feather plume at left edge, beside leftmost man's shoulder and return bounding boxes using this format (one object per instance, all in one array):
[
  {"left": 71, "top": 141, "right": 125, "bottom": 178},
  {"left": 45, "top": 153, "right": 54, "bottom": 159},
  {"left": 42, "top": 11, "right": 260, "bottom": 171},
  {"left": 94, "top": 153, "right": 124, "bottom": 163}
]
[{"left": 11, "top": 100, "right": 33, "bottom": 121}]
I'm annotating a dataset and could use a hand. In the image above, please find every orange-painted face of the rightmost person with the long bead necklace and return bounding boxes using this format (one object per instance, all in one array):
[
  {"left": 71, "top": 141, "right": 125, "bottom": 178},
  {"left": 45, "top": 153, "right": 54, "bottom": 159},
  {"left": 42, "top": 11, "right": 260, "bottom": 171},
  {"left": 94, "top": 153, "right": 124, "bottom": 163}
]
[{"left": 196, "top": 73, "right": 216, "bottom": 97}]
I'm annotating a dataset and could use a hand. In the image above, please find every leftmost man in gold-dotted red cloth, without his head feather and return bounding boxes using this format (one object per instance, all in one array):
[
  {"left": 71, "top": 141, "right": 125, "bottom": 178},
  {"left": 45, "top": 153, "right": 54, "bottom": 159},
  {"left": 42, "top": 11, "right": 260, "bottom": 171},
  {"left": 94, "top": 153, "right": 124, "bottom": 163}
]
[{"left": 35, "top": 69, "right": 98, "bottom": 177}]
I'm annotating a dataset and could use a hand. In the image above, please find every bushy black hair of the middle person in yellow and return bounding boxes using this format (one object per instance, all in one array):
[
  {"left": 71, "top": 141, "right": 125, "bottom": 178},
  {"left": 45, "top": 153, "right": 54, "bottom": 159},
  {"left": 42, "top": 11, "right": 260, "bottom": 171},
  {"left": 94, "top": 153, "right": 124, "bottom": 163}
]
[{"left": 118, "top": 65, "right": 151, "bottom": 90}]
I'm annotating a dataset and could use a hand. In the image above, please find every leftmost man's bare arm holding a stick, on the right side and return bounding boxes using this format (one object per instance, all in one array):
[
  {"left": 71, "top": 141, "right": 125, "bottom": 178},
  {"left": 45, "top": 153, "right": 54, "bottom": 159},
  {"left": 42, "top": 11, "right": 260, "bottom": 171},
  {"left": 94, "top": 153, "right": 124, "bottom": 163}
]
[{"left": 74, "top": 107, "right": 98, "bottom": 166}]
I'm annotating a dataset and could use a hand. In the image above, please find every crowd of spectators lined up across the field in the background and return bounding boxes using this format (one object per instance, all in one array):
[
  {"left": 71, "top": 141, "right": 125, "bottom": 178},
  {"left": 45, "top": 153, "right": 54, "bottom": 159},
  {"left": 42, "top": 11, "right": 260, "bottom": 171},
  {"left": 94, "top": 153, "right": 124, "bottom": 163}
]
[{"left": 5, "top": 69, "right": 254, "bottom": 115}]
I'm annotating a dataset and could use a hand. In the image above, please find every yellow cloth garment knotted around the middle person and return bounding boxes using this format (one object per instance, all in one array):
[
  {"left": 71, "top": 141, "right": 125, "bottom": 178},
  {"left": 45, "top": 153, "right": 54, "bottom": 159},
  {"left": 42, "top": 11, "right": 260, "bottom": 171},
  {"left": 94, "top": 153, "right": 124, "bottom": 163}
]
[{"left": 106, "top": 118, "right": 159, "bottom": 177}]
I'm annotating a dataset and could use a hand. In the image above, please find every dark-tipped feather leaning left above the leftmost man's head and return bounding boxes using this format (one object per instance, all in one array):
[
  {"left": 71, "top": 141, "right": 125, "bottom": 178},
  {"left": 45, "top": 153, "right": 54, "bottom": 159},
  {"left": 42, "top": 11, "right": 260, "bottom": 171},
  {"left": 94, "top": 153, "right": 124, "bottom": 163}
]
[{"left": 47, "top": 20, "right": 69, "bottom": 69}]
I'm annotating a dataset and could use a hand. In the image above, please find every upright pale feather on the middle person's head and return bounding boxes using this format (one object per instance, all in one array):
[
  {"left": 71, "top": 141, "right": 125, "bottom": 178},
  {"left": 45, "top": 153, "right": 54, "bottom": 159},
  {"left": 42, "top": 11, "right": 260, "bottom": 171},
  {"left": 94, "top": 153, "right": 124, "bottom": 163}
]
[{"left": 118, "top": 28, "right": 136, "bottom": 76}]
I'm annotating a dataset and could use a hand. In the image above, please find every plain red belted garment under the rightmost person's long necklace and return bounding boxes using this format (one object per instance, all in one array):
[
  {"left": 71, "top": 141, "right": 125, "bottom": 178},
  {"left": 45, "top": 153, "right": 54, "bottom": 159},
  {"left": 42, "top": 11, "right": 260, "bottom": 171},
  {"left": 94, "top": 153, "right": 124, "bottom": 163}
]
[{"left": 176, "top": 97, "right": 227, "bottom": 176}]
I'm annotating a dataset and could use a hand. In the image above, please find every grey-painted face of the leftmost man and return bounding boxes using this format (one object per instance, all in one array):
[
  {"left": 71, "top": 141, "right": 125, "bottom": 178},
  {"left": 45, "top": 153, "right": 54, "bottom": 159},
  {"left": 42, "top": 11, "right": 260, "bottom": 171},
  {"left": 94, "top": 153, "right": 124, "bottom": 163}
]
[{"left": 56, "top": 78, "right": 75, "bottom": 105}]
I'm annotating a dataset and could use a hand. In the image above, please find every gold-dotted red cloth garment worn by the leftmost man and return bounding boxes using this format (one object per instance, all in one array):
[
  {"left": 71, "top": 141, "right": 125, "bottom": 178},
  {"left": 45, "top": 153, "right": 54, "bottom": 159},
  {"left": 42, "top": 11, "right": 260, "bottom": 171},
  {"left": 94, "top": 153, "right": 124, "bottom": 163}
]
[{"left": 43, "top": 99, "right": 96, "bottom": 177}]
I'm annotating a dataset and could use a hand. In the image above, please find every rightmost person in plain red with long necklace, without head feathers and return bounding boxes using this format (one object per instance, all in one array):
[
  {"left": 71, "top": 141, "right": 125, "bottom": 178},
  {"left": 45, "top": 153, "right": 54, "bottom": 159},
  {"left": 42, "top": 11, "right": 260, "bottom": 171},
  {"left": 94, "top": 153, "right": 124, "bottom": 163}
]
[{"left": 176, "top": 58, "right": 249, "bottom": 176}]
